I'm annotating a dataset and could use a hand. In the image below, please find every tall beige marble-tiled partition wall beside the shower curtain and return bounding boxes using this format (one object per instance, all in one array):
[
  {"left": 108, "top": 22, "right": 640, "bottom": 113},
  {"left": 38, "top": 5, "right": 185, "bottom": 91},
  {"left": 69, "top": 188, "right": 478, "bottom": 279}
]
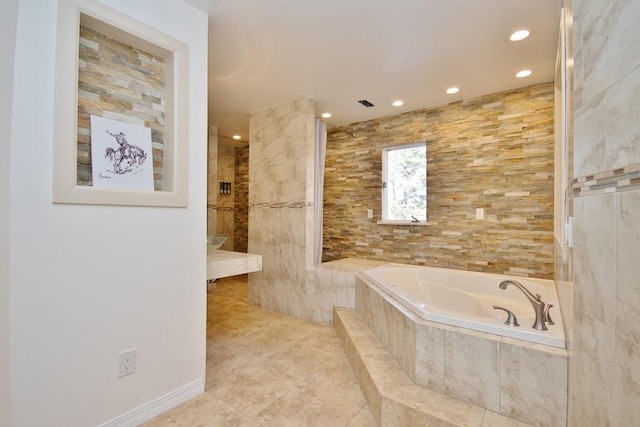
[{"left": 247, "top": 98, "right": 320, "bottom": 322}]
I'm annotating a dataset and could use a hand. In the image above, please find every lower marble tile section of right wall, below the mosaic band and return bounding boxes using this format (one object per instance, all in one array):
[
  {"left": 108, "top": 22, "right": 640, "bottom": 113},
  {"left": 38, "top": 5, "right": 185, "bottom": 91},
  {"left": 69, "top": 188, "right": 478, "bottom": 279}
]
[{"left": 569, "top": 191, "right": 640, "bottom": 426}]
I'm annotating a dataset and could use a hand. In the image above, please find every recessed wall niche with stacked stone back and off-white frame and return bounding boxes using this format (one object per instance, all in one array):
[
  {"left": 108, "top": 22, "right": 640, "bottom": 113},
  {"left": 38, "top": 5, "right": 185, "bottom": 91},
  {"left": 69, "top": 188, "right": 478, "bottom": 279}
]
[{"left": 53, "top": 0, "right": 188, "bottom": 207}]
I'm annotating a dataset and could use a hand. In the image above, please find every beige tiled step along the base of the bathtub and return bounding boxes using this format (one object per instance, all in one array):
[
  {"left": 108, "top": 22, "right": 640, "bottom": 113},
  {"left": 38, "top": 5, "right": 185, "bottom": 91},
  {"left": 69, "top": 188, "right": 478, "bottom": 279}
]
[{"left": 333, "top": 307, "right": 526, "bottom": 427}]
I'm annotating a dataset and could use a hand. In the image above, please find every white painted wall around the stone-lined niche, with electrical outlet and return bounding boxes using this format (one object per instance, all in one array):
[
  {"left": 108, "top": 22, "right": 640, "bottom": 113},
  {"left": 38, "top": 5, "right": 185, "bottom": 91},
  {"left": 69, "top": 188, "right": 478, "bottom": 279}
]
[{"left": 8, "top": 0, "right": 207, "bottom": 427}]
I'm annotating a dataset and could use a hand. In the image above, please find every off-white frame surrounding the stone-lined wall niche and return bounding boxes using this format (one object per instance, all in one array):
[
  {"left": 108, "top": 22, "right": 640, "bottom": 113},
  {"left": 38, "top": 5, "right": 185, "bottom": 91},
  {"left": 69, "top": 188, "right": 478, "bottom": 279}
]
[{"left": 52, "top": 0, "right": 189, "bottom": 207}]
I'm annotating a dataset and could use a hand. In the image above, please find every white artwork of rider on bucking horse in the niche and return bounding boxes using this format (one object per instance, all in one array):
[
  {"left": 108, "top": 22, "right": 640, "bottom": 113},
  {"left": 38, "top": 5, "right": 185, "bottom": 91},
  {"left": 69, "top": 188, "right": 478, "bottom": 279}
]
[{"left": 91, "top": 116, "right": 154, "bottom": 190}]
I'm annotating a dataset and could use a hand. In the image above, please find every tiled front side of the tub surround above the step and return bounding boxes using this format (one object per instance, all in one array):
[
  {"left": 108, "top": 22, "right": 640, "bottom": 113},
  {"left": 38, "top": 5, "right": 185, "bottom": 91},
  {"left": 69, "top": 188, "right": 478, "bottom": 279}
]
[{"left": 355, "top": 274, "right": 567, "bottom": 426}]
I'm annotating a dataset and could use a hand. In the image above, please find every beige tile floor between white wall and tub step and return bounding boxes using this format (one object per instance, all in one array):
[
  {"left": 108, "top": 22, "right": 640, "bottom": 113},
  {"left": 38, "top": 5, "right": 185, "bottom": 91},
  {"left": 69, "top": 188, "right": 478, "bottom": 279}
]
[{"left": 145, "top": 276, "right": 376, "bottom": 427}]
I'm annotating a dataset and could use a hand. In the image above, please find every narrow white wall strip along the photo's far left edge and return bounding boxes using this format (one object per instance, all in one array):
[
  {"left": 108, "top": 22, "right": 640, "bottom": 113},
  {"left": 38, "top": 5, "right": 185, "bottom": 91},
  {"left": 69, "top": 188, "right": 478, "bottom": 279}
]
[{"left": 0, "top": 0, "right": 18, "bottom": 426}]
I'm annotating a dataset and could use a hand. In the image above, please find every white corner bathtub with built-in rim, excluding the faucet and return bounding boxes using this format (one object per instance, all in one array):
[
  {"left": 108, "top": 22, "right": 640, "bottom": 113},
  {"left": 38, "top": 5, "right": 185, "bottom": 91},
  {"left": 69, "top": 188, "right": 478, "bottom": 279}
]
[{"left": 362, "top": 264, "right": 566, "bottom": 348}]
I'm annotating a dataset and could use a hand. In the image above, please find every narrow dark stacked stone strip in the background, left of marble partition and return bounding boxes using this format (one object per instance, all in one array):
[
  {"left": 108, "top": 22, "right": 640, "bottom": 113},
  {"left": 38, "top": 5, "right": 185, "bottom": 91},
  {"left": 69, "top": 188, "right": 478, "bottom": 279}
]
[{"left": 234, "top": 147, "right": 249, "bottom": 252}]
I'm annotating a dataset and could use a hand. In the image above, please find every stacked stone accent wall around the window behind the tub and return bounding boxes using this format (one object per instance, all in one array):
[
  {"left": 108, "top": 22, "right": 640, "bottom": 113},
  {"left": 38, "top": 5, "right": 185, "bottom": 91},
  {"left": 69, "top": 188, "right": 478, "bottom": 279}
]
[{"left": 323, "top": 83, "right": 554, "bottom": 279}]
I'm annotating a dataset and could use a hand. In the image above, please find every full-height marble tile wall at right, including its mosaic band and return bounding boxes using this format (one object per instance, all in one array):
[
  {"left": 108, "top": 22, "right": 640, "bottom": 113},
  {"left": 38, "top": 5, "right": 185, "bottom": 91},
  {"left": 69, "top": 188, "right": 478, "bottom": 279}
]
[{"left": 565, "top": 0, "right": 640, "bottom": 427}]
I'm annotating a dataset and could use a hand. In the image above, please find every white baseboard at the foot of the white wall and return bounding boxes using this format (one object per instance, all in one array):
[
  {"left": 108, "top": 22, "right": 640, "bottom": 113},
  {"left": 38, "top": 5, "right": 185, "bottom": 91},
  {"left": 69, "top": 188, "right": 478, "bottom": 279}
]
[{"left": 98, "top": 379, "right": 204, "bottom": 427}]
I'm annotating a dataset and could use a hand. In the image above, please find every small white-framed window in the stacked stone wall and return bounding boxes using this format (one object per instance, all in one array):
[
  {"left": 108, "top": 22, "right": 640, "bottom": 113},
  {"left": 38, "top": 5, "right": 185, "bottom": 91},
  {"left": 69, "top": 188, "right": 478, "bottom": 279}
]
[{"left": 381, "top": 142, "right": 427, "bottom": 223}]
